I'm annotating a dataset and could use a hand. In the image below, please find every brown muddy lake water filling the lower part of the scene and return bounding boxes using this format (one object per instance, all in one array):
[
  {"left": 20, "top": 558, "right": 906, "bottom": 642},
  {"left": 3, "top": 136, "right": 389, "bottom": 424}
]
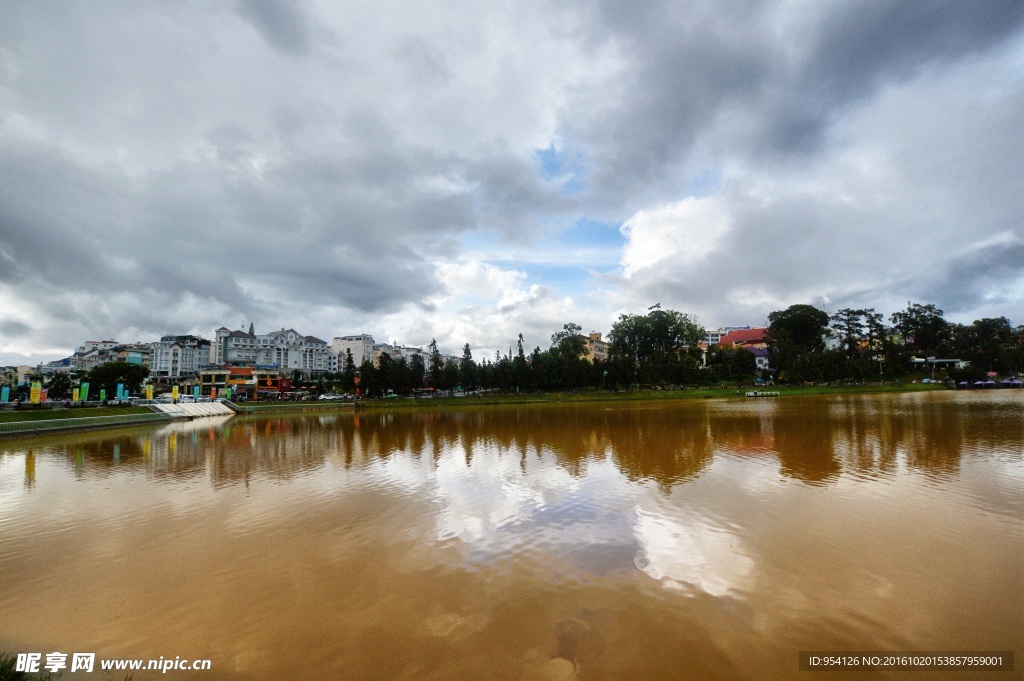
[{"left": 0, "top": 391, "right": 1024, "bottom": 681}]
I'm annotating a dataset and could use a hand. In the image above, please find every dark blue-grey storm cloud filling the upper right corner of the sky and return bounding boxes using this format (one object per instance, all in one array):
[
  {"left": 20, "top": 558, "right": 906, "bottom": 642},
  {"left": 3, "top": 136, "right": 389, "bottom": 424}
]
[{"left": 566, "top": 0, "right": 1024, "bottom": 199}]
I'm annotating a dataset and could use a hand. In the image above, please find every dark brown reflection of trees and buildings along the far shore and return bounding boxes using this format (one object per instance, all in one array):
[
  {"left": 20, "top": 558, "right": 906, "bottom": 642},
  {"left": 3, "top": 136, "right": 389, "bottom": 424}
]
[{"left": 0, "top": 394, "right": 1007, "bottom": 488}]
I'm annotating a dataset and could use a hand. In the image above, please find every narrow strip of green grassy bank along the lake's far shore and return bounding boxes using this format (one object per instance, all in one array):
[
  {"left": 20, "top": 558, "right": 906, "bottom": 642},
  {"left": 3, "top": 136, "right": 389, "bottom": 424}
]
[{"left": 0, "top": 383, "right": 949, "bottom": 435}]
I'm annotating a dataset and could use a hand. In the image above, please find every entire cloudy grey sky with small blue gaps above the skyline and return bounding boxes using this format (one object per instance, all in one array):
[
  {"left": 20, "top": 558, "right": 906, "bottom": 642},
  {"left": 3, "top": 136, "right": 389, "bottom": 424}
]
[{"left": 0, "top": 0, "right": 1024, "bottom": 365}]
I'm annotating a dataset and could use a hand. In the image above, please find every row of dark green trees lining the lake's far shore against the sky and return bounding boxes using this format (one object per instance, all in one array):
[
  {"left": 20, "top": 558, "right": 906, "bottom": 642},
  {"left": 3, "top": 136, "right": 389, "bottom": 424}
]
[{"left": 9, "top": 302, "right": 1024, "bottom": 399}]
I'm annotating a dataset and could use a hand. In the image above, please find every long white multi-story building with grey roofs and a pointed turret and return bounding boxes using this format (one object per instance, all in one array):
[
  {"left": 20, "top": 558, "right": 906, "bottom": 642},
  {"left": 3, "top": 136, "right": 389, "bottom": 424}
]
[{"left": 210, "top": 327, "right": 330, "bottom": 376}]
